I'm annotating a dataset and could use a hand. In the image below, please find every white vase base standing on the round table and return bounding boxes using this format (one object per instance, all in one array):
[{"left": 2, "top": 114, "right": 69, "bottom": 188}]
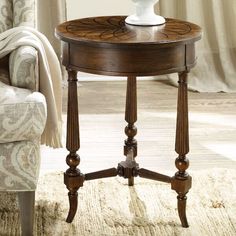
[{"left": 125, "top": 0, "right": 165, "bottom": 26}]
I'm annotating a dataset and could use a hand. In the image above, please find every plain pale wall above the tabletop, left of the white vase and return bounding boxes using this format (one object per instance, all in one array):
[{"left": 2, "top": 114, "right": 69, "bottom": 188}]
[{"left": 67, "top": 0, "right": 134, "bottom": 20}]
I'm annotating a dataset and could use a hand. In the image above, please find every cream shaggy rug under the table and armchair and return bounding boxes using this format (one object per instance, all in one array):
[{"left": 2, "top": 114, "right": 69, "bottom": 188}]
[{"left": 0, "top": 169, "right": 236, "bottom": 236}]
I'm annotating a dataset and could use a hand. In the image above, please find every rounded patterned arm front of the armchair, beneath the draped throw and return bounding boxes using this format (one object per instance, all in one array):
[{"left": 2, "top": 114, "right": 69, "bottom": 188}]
[{"left": 9, "top": 46, "right": 39, "bottom": 91}]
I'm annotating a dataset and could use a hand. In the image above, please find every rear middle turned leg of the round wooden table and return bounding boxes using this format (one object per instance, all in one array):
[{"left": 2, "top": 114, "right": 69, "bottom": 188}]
[{"left": 124, "top": 76, "right": 137, "bottom": 186}]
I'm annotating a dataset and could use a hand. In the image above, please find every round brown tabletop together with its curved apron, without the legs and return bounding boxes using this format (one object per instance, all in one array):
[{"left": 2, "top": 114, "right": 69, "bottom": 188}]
[{"left": 56, "top": 16, "right": 201, "bottom": 76}]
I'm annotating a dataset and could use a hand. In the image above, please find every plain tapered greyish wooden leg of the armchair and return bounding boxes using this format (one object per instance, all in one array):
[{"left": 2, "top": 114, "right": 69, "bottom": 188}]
[{"left": 17, "top": 191, "right": 35, "bottom": 236}]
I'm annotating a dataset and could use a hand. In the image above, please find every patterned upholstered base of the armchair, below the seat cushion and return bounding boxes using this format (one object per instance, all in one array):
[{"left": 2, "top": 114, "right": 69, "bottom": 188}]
[{"left": 0, "top": 139, "right": 40, "bottom": 192}]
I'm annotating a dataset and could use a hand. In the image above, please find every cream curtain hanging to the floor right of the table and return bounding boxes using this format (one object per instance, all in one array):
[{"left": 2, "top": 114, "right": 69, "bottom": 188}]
[{"left": 158, "top": 0, "right": 236, "bottom": 92}]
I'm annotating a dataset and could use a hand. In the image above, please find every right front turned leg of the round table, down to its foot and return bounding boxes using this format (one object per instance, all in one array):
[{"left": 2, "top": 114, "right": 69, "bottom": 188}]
[{"left": 171, "top": 71, "right": 192, "bottom": 227}]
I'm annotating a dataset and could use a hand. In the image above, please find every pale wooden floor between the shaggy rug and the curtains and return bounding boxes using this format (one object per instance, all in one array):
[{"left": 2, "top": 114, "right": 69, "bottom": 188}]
[{"left": 41, "top": 81, "right": 236, "bottom": 173}]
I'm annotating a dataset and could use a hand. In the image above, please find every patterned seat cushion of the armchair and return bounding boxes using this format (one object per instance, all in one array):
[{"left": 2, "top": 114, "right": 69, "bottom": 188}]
[{"left": 0, "top": 82, "right": 47, "bottom": 143}]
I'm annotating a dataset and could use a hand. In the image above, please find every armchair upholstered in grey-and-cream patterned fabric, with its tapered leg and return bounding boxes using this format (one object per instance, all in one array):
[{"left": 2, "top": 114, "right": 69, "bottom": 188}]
[{"left": 0, "top": 0, "right": 47, "bottom": 236}]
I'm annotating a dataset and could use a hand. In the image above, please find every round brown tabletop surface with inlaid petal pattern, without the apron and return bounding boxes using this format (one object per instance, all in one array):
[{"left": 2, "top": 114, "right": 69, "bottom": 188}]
[{"left": 56, "top": 16, "right": 202, "bottom": 44}]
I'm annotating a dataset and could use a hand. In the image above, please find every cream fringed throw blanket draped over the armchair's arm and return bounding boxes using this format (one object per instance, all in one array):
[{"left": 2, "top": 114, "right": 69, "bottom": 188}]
[{"left": 0, "top": 26, "right": 62, "bottom": 148}]
